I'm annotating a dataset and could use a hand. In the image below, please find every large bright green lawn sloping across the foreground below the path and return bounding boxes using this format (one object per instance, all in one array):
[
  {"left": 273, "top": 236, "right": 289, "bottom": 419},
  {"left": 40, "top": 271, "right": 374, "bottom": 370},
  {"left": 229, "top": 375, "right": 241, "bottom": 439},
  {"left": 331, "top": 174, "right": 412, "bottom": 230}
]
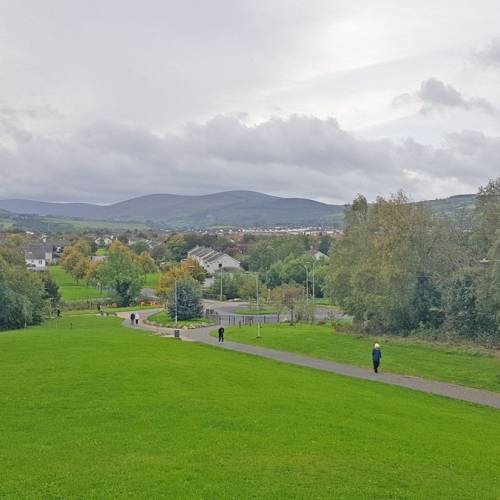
[{"left": 0, "top": 316, "right": 500, "bottom": 500}]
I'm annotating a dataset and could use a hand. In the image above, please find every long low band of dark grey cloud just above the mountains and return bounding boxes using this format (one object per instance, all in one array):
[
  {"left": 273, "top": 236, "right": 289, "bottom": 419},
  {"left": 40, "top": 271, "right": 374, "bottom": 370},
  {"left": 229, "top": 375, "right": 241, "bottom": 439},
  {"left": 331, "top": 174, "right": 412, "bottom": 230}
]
[{"left": 0, "top": 116, "right": 500, "bottom": 203}]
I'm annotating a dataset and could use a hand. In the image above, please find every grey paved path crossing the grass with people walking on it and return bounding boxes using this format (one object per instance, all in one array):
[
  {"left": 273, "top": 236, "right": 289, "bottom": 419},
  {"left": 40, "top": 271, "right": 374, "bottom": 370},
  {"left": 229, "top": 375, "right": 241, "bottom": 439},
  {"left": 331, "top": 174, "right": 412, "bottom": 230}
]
[{"left": 122, "top": 316, "right": 500, "bottom": 409}]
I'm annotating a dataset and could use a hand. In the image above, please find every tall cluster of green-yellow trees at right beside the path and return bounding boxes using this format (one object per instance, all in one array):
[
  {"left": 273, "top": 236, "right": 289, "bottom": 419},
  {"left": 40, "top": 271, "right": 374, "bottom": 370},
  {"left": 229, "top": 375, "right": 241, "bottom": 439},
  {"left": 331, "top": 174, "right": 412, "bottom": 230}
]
[{"left": 326, "top": 178, "right": 500, "bottom": 343}]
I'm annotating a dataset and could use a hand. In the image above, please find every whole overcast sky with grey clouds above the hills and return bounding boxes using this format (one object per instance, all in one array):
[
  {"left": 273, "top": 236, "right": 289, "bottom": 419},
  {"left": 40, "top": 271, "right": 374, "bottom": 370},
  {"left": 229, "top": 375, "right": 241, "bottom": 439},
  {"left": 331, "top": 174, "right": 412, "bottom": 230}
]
[{"left": 0, "top": 0, "right": 500, "bottom": 204}]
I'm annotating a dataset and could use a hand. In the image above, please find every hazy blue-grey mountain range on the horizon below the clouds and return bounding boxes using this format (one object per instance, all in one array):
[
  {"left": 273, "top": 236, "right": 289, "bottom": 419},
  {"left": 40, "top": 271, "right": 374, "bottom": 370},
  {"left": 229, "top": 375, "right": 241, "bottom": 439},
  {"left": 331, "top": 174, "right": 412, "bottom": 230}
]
[{"left": 0, "top": 191, "right": 474, "bottom": 228}]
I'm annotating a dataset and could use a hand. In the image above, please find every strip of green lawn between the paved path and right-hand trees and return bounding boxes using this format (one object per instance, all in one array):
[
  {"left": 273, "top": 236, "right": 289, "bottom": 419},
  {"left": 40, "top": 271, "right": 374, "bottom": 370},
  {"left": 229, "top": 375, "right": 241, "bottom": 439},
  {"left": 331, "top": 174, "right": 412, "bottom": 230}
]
[{"left": 221, "top": 324, "right": 500, "bottom": 392}]
